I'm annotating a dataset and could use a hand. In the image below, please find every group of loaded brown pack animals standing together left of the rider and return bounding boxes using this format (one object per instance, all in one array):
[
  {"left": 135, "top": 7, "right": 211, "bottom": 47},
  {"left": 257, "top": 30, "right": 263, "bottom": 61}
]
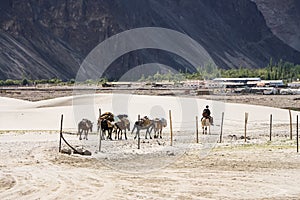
[{"left": 78, "top": 112, "right": 167, "bottom": 140}]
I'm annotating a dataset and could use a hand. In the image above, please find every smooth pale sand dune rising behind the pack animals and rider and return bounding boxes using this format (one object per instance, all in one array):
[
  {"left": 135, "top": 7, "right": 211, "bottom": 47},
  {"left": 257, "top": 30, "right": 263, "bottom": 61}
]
[{"left": 0, "top": 94, "right": 297, "bottom": 130}]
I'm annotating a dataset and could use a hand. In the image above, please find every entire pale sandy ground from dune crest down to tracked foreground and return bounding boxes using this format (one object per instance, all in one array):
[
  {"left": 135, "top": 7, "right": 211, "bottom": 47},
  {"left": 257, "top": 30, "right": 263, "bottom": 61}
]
[{"left": 0, "top": 94, "right": 300, "bottom": 199}]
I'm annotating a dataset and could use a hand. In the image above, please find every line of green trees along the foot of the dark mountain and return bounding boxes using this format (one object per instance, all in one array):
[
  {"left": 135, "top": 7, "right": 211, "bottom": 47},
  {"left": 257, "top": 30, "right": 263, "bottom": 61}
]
[{"left": 0, "top": 59, "right": 300, "bottom": 86}]
